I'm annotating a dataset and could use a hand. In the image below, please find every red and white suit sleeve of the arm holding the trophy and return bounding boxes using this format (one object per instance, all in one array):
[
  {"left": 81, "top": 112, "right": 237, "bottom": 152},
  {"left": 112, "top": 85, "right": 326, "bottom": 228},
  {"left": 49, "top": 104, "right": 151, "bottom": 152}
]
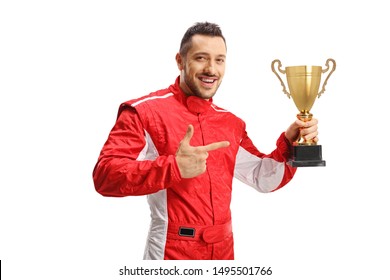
[{"left": 234, "top": 132, "right": 296, "bottom": 192}]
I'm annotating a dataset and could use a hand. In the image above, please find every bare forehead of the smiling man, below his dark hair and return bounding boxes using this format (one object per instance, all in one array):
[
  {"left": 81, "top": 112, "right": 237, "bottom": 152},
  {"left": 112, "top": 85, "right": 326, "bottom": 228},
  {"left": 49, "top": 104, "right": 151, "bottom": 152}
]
[{"left": 188, "top": 34, "right": 226, "bottom": 56}]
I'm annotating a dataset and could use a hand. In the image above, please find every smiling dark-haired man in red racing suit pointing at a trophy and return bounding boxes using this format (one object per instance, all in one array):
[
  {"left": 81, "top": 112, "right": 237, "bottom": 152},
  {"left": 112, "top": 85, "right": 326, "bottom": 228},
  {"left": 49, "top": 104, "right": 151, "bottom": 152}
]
[{"left": 93, "top": 22, "right": 317, "bottom": 259}]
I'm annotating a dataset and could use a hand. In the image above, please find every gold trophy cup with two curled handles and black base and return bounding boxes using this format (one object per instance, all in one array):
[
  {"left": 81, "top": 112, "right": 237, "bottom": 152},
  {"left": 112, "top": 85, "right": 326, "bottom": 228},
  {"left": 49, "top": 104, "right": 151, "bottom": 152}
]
[{"left": 271, "top": 58, "right": 336, "bottom": 167}]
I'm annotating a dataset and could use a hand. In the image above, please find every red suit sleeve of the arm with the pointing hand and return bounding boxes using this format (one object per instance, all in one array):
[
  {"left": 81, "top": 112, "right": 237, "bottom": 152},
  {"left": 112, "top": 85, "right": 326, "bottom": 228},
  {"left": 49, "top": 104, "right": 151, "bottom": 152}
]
[{"left": 93, "top": 107, "right": 181, "bottom": 197}]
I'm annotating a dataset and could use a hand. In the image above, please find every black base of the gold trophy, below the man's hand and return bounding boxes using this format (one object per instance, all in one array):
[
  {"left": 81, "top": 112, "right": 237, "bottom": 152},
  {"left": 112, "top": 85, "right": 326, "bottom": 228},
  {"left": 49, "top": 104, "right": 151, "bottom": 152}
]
[{"left": 287, "top": 145, "right": 326, "bottom": 167}]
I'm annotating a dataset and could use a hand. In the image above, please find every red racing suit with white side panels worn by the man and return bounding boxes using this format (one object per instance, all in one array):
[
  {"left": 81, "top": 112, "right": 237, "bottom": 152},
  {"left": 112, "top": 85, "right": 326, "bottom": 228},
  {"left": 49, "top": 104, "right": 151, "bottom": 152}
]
[{"left": 93, "top": 77, "right": 296, "bottom": 259}]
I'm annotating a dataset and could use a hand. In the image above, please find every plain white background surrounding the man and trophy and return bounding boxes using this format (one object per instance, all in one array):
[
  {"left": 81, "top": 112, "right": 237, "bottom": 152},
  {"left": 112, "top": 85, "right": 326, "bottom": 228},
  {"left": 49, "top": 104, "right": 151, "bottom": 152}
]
[{"left": 0, "top": 0, "right": 390, "bottom": 280}]
